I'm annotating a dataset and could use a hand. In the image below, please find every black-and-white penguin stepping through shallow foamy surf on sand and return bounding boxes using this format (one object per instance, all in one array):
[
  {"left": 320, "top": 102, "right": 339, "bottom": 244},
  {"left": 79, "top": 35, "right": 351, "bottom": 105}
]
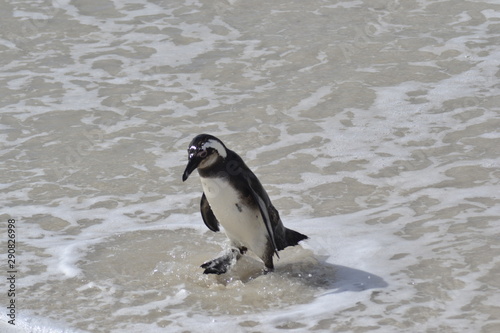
[{"left": 182, "top": 134, "right": 308, "bottom": 274}]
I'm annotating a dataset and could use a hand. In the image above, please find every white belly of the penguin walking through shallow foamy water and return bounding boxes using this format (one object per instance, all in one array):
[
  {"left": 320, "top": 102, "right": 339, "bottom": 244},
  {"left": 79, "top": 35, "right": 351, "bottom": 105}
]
[{"left": 201, "top": 178, "right": 268, "bottom": 257}]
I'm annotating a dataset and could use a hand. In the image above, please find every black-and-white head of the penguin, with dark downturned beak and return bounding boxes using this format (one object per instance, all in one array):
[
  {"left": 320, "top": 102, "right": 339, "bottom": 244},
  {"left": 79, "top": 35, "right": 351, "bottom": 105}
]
[{"left": 182, "top": 134, "right": 227, "bottom": 181}]
